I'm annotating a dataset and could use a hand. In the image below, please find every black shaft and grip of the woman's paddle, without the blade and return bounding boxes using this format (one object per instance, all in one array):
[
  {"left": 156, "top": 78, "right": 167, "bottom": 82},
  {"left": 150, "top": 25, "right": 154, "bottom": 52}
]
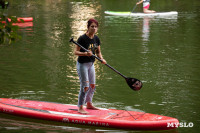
[{"left": 69, "top": 38, "right": 127, "bottom": 79}]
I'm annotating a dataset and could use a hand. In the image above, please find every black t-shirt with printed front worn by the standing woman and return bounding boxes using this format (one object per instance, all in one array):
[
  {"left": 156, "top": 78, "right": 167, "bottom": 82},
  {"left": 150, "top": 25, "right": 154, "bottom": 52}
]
[{"left": 77, "top": 34, "right": 100, "bottom": 63}]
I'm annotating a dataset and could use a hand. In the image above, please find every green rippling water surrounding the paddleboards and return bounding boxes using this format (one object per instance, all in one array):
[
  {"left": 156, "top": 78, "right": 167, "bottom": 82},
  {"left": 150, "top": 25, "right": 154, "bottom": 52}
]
[{"left": 0, "top": 0, "right": 200, "bottom": 133}]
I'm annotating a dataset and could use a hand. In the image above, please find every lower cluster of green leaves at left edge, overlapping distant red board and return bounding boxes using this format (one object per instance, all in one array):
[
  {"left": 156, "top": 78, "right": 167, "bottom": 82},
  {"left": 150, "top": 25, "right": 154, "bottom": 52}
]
[{"left": 0, "top": 14, "right": 23, "bottom": 45}]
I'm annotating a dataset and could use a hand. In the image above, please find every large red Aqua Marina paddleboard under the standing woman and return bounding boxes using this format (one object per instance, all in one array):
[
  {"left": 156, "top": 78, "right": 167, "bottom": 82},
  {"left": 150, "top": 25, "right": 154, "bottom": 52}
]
[{"left": 0, "top": 98, "right": 179, "bottom": 130}]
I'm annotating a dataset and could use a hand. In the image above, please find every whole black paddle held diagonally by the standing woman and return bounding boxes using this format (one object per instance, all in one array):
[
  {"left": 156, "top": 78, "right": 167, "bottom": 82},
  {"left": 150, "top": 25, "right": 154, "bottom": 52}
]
[{"left": 69, "top": 38, "right": 142, "bottom": 91}]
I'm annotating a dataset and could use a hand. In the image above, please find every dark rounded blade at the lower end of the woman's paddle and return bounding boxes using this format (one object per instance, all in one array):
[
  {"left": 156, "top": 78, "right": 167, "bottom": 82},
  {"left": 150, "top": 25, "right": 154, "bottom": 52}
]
[{"left": 126, "top": 78, "right": 142, "bottom": 91}]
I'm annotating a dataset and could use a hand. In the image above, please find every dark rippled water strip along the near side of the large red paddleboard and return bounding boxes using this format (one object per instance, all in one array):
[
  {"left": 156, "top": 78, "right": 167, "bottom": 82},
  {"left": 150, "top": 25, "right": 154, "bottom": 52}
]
[{"left": 0, "top": 113, "right": 127, "bottom": 133}]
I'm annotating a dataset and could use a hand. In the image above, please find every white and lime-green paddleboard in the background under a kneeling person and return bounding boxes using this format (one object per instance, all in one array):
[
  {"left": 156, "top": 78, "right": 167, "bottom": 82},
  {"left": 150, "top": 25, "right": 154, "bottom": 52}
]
[{"left": 105, "top": 11, "right": 178, "bottom": 17}]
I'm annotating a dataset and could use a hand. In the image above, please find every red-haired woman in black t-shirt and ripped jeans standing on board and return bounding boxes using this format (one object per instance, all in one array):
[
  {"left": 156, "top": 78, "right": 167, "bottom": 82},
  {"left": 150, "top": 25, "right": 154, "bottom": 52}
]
[{"left": 74, "top": 19, "right": 106, "bottom": 114}]
